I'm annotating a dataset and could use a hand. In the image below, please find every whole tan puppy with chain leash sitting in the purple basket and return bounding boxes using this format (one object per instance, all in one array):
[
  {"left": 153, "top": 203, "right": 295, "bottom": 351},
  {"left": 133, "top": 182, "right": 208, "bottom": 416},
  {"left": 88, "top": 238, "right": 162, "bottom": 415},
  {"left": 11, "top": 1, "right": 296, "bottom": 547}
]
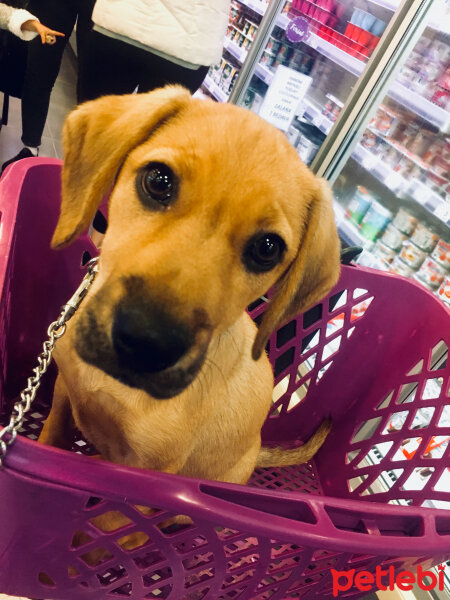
[{"left": 40, "top": 87, "right": 339, "bottom": 483}]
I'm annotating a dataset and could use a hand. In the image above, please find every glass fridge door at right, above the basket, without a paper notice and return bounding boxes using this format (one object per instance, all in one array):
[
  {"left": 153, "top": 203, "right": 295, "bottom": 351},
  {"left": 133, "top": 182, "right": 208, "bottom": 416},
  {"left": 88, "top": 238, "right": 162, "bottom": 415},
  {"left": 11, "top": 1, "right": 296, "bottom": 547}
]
[{"left": 333, "top": 13, "right": 450, "bottom": 305}]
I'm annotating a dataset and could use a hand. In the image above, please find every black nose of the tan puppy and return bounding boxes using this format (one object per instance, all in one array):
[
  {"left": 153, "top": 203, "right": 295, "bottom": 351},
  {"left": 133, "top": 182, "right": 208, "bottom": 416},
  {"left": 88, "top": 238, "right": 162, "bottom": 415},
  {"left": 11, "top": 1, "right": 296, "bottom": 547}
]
[{"left": 112, "top": 303, "right": 190, "bottom": 373}]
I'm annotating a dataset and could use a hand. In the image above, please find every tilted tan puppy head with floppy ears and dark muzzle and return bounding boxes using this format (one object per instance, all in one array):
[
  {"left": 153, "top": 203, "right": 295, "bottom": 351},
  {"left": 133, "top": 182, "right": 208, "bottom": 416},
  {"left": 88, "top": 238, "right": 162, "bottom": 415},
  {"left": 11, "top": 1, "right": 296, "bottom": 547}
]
[{"left": 52, "top": 86, "right": 339, "bottom": 398}]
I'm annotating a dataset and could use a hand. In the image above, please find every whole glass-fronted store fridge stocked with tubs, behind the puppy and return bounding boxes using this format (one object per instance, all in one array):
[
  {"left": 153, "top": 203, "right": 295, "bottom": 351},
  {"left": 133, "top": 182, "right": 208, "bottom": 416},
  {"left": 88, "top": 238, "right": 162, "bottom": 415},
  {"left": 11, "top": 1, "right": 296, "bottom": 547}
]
[{"left": 208, "top": 0, "right": 450, "bottom": 305}]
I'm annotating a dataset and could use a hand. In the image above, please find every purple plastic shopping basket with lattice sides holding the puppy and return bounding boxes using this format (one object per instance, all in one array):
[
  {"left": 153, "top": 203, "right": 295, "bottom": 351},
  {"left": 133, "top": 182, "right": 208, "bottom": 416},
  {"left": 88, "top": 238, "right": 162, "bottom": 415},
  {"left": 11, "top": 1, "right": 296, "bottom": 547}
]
[{"left": 0, "top": 159, "right": 450, "bottom": 600}]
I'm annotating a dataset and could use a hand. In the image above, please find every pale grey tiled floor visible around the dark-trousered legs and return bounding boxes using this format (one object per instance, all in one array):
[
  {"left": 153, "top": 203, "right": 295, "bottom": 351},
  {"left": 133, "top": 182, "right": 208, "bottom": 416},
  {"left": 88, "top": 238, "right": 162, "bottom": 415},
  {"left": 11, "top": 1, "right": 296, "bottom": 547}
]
[{"left": 0, "top": 49, "right": 76, "bottom": 165}]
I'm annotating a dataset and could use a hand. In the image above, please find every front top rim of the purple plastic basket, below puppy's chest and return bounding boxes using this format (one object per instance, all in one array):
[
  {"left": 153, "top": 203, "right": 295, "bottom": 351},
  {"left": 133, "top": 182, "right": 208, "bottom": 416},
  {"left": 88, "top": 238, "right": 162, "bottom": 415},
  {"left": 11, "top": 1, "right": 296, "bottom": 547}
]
[{"left": 0, "top": 436, "right": 450, "bottom": 558}]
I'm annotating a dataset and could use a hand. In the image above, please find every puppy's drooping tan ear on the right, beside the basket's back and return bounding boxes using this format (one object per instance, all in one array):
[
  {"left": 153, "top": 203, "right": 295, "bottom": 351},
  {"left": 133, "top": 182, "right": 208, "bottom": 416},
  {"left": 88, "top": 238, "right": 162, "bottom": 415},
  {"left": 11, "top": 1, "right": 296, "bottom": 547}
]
[{"left": 252, "top": 179, "right": 340, "bottom": 360}]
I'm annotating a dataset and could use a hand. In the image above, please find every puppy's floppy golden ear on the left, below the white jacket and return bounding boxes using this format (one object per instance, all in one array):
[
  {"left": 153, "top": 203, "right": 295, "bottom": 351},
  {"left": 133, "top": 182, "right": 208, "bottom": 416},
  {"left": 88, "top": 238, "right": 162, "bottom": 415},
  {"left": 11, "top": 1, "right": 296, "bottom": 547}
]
[{"left": 52, "top": 86, "right": 191, "bottom": 248}]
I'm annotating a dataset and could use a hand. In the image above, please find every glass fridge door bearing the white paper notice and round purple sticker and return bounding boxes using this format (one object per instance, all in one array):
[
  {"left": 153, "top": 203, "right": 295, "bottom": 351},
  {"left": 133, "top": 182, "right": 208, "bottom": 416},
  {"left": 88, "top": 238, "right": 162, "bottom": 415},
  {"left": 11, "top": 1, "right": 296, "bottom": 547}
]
[{"left": 227, "top": 0, "right": 400, "bottom": 165}]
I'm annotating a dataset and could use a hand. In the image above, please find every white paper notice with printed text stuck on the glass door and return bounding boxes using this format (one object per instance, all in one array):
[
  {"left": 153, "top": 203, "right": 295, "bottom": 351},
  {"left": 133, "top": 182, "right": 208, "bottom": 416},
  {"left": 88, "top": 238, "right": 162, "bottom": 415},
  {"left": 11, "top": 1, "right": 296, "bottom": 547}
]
[{"left": 259, "top": 65, "right": 312, "bottom": 131}]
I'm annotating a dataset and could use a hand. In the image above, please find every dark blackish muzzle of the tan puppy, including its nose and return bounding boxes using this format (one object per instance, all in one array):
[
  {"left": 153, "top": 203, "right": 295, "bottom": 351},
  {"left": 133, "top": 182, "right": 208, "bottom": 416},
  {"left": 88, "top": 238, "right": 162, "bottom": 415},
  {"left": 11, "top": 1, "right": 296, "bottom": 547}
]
[{"left": 75, "top": 293, "right": 211, "bottom": 399}]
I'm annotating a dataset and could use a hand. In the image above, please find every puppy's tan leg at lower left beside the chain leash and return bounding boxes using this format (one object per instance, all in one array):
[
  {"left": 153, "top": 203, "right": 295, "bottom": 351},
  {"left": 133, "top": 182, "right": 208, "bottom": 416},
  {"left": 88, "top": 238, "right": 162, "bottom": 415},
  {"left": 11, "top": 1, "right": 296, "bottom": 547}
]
[{"left": 39, "top": 374, "right": 75, "bottom": 450}]
